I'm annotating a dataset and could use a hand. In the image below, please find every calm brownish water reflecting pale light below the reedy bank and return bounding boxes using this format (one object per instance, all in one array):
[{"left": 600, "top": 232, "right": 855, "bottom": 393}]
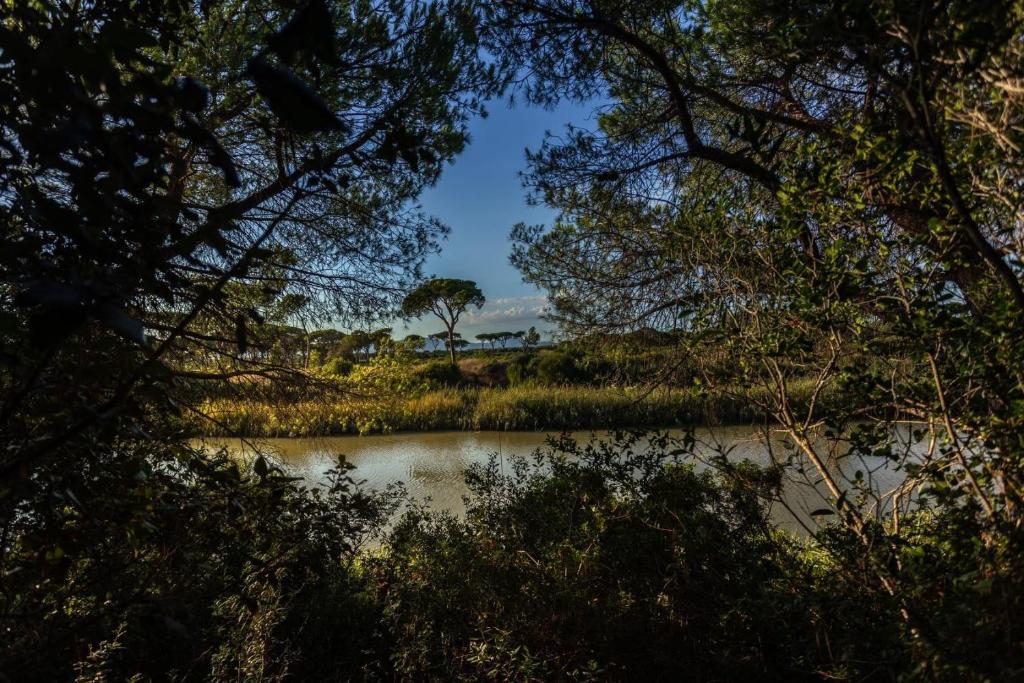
[{"left": 195, "top": 427, "right": 903, "bottom": 532}]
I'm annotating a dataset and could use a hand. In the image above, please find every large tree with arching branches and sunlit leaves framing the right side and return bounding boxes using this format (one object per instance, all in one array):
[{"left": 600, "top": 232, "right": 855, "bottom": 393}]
[{"left": 487, "top": 0, "right": 1024, "bottom": 679}]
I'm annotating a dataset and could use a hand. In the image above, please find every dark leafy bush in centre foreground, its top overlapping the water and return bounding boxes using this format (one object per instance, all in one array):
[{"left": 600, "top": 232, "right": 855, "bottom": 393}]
[{"left": 370, "top": 437, "right": 867, "bottom": 681}]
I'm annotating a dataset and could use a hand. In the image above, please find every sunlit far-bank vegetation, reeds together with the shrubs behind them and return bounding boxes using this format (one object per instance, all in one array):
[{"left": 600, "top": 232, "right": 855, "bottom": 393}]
[{"left": 184, "top": 339, "right": 834, "bottom": 438}]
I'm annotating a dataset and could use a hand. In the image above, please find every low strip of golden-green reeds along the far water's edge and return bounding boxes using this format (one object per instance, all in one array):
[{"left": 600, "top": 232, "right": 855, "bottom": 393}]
[{"left": 188, "top": 386, "right": 819, "bottom": 436}]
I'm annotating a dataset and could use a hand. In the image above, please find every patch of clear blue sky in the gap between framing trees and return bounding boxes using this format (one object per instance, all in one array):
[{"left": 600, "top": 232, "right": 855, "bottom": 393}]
[{"left": 394, "top": 100, "right": 593, "bottom": 339}]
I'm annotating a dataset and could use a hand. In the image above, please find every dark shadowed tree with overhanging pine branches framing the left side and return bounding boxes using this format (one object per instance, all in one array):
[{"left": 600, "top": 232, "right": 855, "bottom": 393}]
[{"left": 0, "top": 0, "right": 493, "bottom": 680}]
